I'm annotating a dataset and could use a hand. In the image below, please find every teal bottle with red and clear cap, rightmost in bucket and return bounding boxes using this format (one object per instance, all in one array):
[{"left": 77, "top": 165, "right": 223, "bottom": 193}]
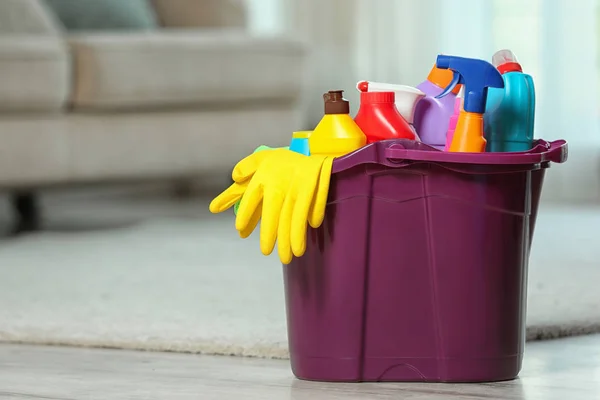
[{"left": 484, "top": 50, "right": 535, "bottom": 152}]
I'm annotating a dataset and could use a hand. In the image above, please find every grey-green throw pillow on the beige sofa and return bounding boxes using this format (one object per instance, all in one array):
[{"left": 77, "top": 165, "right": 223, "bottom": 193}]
[{"left": 46, "top": 0, "right": 158, "bottom": 31}]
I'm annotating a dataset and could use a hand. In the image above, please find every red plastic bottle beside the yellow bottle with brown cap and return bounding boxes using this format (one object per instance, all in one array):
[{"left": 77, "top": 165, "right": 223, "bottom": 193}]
[{"left": 354, "top": 92, "right": 417, "bottom": 144}]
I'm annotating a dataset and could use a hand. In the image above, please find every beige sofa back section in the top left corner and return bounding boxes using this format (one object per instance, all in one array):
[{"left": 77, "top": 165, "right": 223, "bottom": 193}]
[{"left": 0, "top": 0, "right": 61, "bottom": 36}]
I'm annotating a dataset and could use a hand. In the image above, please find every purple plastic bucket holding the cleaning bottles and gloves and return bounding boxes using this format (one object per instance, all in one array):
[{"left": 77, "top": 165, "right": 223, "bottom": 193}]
[{"left": 283, "top": 140, "right": 567, "bottom": 382}]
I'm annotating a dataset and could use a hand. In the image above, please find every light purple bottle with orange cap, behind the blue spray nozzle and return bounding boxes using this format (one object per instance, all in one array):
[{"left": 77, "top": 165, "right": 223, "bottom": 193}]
[{"left": 413, "top": 65, "right": 460, "bottom": 150}]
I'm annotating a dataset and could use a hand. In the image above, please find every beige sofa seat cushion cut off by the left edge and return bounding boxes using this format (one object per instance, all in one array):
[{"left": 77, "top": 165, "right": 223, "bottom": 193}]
[{"left": 0, "top": 36, "right": 71, "bottom": 113}]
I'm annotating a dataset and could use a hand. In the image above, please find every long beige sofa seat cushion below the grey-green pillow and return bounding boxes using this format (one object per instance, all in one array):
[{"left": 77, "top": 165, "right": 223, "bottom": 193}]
[{"left": 69, "top": 31, "right": 304, "bottom": 109}]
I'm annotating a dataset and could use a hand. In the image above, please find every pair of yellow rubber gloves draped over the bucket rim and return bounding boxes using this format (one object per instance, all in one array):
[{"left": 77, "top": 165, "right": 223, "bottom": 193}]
[{"left": 210, "top": 149, "right": 333, "bottom": 264}]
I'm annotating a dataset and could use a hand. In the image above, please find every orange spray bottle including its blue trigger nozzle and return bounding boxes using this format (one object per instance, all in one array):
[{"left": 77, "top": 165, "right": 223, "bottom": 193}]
[{"left": 436, "top": 55, "right": 504, "bottom": 153}]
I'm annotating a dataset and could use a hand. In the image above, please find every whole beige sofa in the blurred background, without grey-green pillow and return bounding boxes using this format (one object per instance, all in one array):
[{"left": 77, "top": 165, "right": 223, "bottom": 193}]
[{"left": 0, "top": 0, "right": 306, "bottom": 230}]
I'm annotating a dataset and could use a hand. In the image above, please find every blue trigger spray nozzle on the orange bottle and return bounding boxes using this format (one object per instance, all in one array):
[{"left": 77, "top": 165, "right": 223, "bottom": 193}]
[{"left": 436, "top": 55, "right": 504, "bottom": 114}]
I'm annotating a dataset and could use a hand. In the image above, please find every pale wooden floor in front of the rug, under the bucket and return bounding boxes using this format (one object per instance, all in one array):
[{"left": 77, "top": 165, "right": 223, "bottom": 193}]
[{"left": 0, "top": 335, "right": 600, "bottom": 400}]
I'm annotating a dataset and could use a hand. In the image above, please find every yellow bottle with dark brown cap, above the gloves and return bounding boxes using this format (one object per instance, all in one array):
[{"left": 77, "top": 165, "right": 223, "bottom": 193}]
[{"left": 308, "top": 90, "right": 367, "bottom": 157}]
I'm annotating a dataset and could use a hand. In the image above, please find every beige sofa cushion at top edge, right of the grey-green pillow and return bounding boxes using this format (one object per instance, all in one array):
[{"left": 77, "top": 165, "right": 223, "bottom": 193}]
[{"left": 152, "top": 0, "right": 247, "bottom": 28}]
